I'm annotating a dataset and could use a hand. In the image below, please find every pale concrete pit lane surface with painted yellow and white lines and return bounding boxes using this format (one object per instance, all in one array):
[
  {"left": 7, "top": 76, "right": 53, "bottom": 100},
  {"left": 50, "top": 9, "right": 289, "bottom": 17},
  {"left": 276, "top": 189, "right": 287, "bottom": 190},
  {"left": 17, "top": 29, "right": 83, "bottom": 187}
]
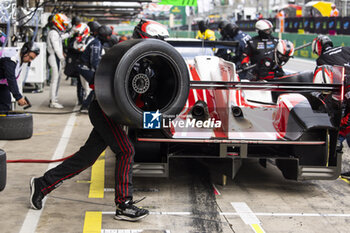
[{"left": 0, "top": 57, "right": 350, "bottom": 233}]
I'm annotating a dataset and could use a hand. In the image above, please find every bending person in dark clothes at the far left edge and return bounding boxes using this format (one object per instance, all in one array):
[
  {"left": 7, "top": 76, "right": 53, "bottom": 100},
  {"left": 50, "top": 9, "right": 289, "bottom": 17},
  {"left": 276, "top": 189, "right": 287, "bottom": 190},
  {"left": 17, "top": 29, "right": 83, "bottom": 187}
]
[{"left": 0, "top": 42, "right": 40, "bottom": 112}]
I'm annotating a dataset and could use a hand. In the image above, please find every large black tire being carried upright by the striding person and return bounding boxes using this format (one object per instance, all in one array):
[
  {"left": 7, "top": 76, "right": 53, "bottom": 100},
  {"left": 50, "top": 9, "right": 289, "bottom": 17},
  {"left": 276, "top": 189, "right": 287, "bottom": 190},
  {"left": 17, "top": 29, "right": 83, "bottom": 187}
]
[{"left": 95, "top": 39, "right": 189, "bottom": 127}]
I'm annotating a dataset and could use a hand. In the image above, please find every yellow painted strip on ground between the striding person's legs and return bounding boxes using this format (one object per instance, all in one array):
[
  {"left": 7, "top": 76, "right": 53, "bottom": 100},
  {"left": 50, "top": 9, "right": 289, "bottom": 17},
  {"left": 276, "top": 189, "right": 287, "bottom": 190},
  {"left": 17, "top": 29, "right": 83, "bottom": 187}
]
[{"left": 89, "top": 151, "right": 105, "bottom": 198}]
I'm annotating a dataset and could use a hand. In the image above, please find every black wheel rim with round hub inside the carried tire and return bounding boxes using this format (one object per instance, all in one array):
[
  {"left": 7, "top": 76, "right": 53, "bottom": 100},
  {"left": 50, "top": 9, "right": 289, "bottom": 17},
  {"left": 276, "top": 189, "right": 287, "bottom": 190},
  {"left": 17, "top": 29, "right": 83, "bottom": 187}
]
[{"left": 126, "top": 52, "right": 180, "bottom": 112}]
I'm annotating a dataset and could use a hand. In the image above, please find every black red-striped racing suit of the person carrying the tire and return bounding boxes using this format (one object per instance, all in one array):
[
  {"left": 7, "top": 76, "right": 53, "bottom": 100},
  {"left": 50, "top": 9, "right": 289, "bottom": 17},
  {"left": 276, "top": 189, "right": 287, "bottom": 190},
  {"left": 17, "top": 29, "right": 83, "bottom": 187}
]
[{"left": 38, "top": 36, "right": 135, "bottom": 204}]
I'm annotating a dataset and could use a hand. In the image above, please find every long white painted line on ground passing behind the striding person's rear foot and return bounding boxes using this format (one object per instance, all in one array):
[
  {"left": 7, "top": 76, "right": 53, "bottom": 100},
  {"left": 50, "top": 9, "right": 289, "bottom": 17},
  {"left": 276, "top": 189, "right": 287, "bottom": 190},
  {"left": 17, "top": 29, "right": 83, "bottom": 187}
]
[{"left": 20, "top": 106, "right": 78, "bottom": 233}]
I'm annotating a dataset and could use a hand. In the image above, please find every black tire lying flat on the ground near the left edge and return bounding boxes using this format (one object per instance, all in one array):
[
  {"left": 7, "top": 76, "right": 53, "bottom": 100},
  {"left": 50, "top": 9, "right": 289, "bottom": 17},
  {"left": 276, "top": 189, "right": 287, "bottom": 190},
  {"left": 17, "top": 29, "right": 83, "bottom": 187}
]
[{"left": 0, "top": 112, "right": 33, "bottom": 140}]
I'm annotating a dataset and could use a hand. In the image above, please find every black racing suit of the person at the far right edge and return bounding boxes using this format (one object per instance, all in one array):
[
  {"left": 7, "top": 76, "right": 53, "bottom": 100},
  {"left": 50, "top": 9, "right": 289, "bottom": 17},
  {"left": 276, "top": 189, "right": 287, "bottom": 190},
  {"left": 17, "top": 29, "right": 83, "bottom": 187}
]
[{"left": 316, "top": 47, "right": 350, "bottom": 145}]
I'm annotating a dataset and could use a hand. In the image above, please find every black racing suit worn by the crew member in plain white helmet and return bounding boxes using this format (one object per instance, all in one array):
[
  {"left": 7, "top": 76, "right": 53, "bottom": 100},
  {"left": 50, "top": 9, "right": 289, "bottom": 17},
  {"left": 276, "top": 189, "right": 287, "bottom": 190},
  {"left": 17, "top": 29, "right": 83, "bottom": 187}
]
[{"left": 242, "top": 36, "right": 285, "bottom": 80}]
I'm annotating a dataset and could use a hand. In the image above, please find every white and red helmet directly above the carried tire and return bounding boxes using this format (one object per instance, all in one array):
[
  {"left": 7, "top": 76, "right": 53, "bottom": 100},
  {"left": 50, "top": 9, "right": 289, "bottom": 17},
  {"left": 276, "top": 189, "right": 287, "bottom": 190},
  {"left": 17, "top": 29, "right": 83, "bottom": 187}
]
[{"left": 132, "top": 19, "right": 169, "bottom": 39}]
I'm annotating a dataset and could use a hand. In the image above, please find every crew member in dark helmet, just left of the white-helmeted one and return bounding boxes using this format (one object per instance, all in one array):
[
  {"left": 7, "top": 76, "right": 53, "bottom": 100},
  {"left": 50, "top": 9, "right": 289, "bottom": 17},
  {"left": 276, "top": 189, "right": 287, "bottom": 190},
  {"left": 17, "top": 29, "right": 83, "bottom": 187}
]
[{"left": 215, "top": 23, "right": 252, "bottom": 79}]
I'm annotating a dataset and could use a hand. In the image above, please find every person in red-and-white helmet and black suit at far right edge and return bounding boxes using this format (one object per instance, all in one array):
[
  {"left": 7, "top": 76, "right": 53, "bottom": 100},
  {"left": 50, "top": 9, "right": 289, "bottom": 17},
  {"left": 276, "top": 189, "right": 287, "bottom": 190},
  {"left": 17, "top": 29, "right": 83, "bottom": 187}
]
[{"left": 312, "top": 35, "right": 350, "bottom": 179}]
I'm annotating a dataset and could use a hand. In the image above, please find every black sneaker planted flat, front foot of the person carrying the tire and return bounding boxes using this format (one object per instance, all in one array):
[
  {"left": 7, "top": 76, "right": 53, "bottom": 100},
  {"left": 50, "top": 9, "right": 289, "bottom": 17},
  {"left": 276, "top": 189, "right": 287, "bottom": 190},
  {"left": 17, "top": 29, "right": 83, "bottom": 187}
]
[{"left": 114, "top": 201, "right": 149, "bottom": 222}]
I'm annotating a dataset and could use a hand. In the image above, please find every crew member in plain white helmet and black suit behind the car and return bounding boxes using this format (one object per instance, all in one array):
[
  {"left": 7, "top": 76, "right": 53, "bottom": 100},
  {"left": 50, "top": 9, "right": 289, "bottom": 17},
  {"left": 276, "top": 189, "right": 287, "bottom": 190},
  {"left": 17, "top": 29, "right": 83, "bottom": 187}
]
[{"left": 241, "top": 19, "right": 284, "bottom": 80}]
